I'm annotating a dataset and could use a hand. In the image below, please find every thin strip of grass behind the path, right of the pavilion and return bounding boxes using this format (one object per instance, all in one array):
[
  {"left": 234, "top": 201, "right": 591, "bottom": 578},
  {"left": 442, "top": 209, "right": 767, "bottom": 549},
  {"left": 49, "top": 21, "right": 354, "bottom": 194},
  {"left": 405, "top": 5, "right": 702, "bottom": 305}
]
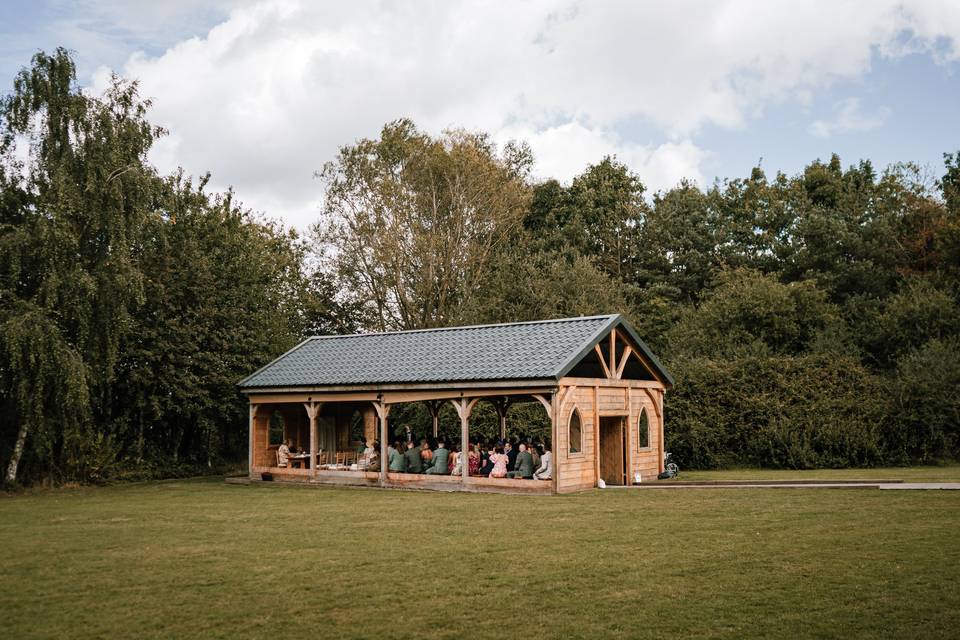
[{"left": 680, "top": 464, "right": 960, "bottom": 482}]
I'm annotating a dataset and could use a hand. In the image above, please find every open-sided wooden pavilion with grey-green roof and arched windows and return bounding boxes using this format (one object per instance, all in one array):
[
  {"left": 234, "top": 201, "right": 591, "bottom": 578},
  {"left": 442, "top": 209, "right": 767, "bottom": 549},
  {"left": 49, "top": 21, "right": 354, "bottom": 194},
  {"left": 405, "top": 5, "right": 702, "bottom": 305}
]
[{"left": 239, "top": 315, "right": 673, "bottom": 493}]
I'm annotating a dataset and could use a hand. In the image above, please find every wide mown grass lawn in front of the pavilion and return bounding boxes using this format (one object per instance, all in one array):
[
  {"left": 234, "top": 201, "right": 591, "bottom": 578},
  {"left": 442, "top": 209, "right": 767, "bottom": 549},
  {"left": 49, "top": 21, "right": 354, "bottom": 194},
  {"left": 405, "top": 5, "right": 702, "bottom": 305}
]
[{"left": 0, "top": 474, "right": 960, "bottom": 639}]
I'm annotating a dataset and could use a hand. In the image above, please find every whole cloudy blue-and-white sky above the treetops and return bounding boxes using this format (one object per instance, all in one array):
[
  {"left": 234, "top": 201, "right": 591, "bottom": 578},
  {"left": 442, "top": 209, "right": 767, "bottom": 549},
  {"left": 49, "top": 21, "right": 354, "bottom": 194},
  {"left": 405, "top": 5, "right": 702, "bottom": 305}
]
[{"left": 0, "top": 0, "right": 960, "bottom": 228}]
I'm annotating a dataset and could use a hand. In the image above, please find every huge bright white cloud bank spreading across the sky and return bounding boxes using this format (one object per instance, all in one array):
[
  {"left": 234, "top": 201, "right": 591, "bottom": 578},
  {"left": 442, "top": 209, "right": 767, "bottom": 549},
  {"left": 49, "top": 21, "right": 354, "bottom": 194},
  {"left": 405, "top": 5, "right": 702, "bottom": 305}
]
[{"left": 80, "top": 0, "right": 960, "bottom": 226}]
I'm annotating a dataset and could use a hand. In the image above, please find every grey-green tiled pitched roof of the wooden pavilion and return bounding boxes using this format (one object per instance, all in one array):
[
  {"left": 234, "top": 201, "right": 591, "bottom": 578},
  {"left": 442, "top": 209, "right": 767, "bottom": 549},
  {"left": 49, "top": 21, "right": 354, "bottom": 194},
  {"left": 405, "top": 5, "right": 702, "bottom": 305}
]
[{"left": 239, "top": 315, "right": 673, "bottom": 389}]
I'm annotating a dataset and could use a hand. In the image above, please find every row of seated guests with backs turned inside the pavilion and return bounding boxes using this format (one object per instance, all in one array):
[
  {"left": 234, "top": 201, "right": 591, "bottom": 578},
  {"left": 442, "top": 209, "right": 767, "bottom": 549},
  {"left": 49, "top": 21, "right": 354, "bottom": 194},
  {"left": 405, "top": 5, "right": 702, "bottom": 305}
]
[{"left": 387, "top": 439, "right": 553, "bottom": 480}]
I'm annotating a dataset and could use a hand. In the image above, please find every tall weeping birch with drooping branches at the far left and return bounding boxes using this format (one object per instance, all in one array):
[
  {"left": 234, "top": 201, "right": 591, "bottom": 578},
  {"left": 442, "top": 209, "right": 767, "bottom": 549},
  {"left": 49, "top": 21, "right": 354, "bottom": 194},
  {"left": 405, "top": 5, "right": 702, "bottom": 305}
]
[{"left": 0, "top": 49, "right": 162, "bottom": 477}]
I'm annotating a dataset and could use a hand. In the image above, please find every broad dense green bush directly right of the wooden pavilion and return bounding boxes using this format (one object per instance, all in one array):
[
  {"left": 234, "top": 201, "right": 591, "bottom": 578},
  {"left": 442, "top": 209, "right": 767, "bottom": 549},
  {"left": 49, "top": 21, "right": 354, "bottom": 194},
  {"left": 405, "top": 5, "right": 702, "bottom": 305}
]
[{"left": 665, "top": 355, "right": 888, "bottom": 469}]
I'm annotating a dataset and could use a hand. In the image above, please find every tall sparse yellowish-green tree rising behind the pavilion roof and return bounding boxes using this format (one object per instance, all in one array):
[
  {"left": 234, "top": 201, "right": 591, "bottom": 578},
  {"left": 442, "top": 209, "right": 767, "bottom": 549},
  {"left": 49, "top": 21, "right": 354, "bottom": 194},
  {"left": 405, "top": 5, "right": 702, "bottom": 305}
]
[{"left": 313, "top": 120, "right": 530, "bottom": 330}]
